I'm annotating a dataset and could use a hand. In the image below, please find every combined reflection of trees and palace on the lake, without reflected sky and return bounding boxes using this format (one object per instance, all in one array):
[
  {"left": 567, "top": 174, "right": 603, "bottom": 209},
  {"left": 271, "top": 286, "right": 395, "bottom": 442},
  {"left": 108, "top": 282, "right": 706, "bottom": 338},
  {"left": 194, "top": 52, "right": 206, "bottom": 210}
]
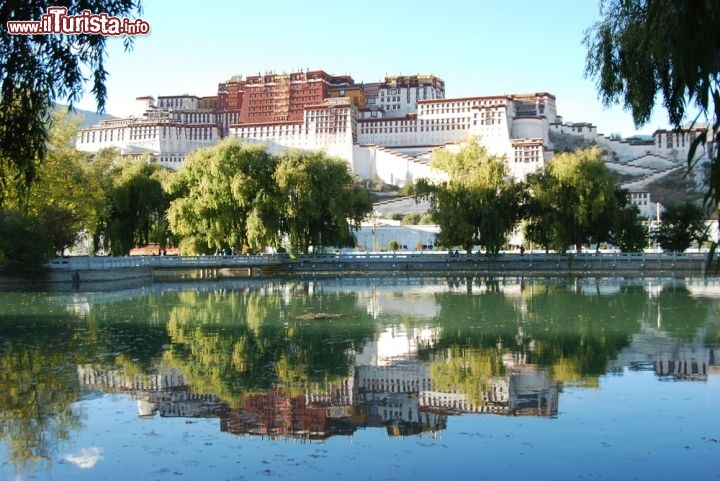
[{"left": 0, "top": 278, "right": 720, "bottom": 478}]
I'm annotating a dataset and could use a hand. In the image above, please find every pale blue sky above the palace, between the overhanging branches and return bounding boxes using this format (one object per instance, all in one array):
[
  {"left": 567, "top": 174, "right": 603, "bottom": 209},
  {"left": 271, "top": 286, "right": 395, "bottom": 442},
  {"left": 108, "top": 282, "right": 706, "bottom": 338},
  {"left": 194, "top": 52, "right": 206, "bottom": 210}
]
[{"left": 78, "top": 0, "right": 668, "bottom": 136}]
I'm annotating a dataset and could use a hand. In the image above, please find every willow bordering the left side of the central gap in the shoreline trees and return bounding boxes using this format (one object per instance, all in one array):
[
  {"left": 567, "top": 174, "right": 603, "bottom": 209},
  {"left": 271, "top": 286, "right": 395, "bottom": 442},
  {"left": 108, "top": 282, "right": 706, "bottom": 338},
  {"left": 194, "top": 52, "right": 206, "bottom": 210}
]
[{"left": 275, "top": 150, "right": 372, "bottom": 254}]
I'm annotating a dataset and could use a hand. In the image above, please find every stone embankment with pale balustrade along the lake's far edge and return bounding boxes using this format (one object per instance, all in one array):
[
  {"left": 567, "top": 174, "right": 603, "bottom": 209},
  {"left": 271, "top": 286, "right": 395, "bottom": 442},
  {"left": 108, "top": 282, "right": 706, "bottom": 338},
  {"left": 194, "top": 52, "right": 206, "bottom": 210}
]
[{"left": 0, "top": 252, "right": 707, "bottom": 292}]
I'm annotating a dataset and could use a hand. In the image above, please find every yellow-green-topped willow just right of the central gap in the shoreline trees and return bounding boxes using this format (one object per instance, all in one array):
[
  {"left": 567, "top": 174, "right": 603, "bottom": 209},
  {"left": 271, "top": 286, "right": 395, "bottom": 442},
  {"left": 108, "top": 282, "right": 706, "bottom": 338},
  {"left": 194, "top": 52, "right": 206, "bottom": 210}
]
[{"left": 416, "top": 138, "right": 521, "bottom": 255}]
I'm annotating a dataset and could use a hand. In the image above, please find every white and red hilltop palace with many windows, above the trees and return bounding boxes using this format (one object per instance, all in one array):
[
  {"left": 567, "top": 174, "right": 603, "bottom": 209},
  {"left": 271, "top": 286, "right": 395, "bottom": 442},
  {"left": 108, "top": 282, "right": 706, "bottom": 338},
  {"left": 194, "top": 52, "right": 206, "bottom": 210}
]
[{"left": 76, "top": 70, "right": 705, "bottom": 217}]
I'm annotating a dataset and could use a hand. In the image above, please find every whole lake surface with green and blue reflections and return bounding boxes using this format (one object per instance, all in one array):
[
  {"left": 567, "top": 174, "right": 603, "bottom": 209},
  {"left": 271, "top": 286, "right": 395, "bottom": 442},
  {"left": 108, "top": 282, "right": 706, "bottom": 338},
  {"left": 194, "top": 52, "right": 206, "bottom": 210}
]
[{"left": 0, "top": 277, "right": 720, "bottom": 481}]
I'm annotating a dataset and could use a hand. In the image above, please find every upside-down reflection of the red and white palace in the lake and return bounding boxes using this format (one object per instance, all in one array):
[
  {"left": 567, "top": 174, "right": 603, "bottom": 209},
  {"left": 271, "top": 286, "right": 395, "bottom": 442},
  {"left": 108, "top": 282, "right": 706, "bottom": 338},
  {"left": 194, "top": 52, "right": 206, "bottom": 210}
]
[{"left": 78, "top": 344, "right": 559, "bottom": 439}]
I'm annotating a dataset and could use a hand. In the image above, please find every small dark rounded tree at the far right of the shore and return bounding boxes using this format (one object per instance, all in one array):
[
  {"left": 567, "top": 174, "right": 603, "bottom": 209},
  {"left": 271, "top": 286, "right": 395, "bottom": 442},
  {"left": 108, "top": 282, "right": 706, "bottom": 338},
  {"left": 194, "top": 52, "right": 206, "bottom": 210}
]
[{"left": 655, "top": 202, "right": 707, "bottom": 252}]
